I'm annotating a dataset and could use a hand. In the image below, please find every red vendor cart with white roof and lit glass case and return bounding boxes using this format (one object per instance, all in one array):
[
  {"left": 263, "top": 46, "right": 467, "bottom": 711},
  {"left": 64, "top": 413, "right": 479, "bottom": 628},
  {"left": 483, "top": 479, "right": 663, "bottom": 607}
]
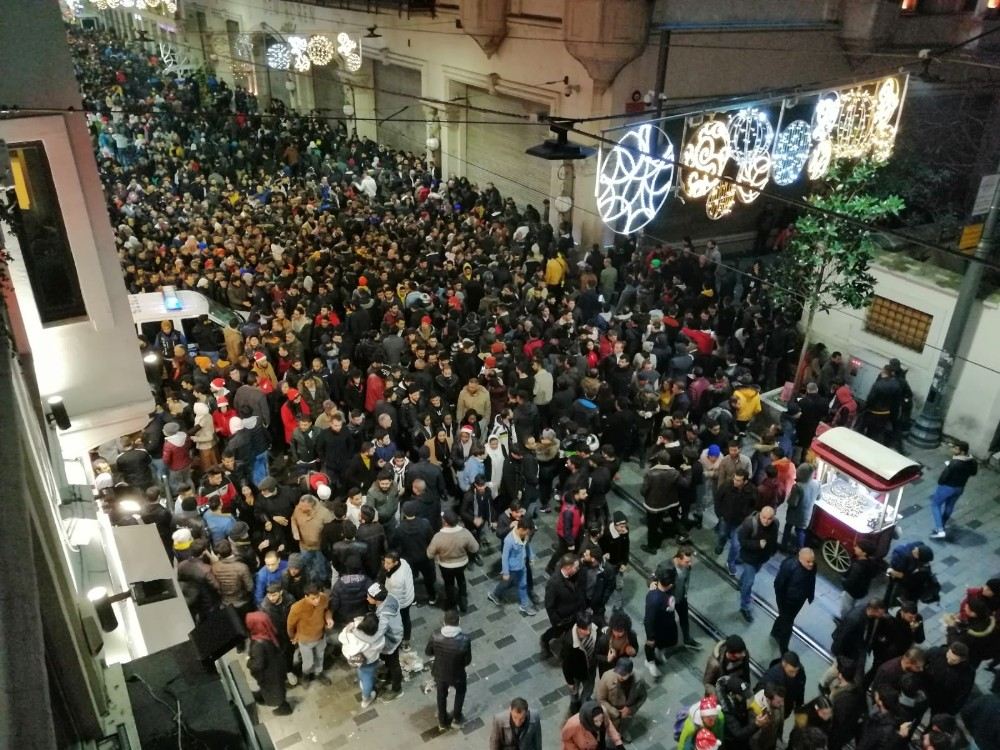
[{"left": 809, "top": 427, "right": 922, "bottom": 573}]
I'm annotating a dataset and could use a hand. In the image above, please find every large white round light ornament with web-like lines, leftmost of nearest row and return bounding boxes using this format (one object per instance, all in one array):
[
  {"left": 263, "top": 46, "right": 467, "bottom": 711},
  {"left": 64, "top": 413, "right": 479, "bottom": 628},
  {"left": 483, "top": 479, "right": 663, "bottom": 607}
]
[{"left": 596, "top": 123, "right": 674, "bottom": 234}]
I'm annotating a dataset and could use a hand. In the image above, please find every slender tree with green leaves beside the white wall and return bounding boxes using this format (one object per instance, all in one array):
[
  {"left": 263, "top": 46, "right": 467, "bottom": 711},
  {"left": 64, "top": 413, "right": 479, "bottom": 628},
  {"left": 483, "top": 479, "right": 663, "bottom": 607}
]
[{"left": 770, "top": 161, "right": 904, "bottom": 392}]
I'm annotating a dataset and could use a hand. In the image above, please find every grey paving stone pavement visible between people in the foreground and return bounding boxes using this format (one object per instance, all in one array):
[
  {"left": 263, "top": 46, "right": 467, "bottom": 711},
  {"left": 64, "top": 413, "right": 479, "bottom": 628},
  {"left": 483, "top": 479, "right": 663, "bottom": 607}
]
[{"left": 246, "top": 448, "right": 1000, "bottom": 750}]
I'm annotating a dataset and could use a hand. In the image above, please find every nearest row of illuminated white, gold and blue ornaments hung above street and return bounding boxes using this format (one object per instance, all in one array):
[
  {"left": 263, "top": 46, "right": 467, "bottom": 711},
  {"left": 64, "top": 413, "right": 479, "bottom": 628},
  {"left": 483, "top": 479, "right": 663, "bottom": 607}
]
[{"left": 596, "top": 75, "right": 912, "bottom": 233}]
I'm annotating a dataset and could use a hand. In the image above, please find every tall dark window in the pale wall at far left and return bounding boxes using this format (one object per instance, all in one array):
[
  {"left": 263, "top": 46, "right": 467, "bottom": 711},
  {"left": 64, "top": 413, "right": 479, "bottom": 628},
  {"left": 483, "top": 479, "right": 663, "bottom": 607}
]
[{"left": 10, "top": 142, "right": 87, "bottom": 325}]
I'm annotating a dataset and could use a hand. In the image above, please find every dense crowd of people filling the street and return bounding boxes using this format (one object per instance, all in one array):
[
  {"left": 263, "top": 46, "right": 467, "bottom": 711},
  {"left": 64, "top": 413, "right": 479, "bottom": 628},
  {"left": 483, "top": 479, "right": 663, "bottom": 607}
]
[{"left": 70, "top": 26, "right": 1000, "bottom": 750}]
